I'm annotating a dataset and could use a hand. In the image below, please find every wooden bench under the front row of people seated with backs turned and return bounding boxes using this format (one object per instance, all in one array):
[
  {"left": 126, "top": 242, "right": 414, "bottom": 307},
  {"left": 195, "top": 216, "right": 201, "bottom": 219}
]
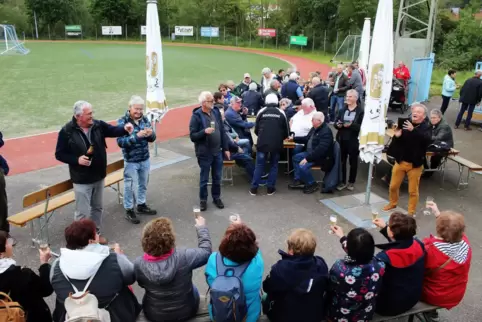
[{"left": 184, "top": 296, "right": 439, "bottom": 322}]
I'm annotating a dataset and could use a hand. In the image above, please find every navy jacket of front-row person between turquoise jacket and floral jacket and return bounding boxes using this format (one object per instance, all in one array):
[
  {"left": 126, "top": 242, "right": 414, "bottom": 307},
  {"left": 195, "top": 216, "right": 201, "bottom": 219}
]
[{"left": 263, "top": 250, "right": 328, "bottom": 322}]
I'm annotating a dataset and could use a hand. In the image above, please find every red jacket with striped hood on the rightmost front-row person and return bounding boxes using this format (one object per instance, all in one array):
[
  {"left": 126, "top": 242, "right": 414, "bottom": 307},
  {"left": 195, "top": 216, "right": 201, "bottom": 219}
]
[{"left": 422, "top": 235, "right": 472, "bottom": 309}]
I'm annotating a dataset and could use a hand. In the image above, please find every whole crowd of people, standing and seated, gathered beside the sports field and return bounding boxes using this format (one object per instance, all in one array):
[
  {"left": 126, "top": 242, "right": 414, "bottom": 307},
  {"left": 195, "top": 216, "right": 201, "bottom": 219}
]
[{"left": 0, "top": 62, "right": 474, "bottom": 322}]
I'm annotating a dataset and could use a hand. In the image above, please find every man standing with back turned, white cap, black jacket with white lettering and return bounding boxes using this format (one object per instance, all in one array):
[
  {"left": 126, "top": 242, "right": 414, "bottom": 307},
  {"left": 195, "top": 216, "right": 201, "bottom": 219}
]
[{"left": 249, "top": 94, "right": 289, "bottom": 196}]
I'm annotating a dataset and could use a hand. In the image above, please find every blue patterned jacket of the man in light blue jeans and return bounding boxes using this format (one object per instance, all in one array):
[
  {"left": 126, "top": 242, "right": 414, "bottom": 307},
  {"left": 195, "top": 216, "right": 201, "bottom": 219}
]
[{"left": 117, "top": 111, "right": 156, "bottom": 162}]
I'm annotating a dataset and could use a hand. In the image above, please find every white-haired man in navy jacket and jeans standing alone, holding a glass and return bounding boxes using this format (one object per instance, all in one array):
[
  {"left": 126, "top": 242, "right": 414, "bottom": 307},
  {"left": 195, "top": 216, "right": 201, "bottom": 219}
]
[{"left": 189, "top": 92, "right": 231, "bottom": 211}]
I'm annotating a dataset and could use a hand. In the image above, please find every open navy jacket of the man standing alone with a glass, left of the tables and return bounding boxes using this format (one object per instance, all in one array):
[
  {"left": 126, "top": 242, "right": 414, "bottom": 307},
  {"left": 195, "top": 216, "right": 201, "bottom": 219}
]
[{"left": 189, "top": 107, "right": 229, "bottom": 157}]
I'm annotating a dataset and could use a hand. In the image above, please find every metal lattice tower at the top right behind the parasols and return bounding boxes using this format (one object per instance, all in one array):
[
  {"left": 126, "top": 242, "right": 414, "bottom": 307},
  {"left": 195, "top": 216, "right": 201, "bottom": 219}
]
[{"left": 394, "top": 0, "right": 438, "bottom": 56}]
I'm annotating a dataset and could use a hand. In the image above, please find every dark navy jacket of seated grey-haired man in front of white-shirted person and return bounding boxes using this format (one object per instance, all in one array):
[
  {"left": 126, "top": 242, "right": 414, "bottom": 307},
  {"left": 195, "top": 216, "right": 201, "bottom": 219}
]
[{"left": 294, "top": 123, "right": 333, "bottom": 165}]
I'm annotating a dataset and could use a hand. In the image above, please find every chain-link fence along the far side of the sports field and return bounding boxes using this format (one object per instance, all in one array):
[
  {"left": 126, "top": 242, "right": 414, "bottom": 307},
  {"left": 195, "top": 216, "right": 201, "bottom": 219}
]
[{"left": 19, "top": 23, "right": 358, "bottom": 55}]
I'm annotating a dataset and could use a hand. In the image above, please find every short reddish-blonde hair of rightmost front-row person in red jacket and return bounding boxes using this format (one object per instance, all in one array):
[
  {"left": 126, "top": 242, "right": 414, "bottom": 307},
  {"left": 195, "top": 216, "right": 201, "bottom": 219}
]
[{"left": 435, "top": 210, "right": 465, "bottom": 243}]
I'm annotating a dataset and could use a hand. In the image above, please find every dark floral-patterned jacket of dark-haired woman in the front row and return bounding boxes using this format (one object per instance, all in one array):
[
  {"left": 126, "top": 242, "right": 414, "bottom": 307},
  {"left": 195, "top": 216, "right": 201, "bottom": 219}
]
[{"left": 326, "top": 255, "right": 385, "bottom": 322}]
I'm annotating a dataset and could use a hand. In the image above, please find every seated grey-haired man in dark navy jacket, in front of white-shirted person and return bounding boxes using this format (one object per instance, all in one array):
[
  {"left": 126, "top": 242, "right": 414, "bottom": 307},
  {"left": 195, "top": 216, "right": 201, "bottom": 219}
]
[{"left": 288, "top": 112, "right": 333, "bottom": 193}]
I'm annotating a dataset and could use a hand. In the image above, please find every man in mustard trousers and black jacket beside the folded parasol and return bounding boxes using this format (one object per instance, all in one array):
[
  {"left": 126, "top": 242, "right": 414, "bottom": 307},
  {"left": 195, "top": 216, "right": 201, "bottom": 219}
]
[{"left": 383, "top": 103, "right": 431, "bottom": 216}]
